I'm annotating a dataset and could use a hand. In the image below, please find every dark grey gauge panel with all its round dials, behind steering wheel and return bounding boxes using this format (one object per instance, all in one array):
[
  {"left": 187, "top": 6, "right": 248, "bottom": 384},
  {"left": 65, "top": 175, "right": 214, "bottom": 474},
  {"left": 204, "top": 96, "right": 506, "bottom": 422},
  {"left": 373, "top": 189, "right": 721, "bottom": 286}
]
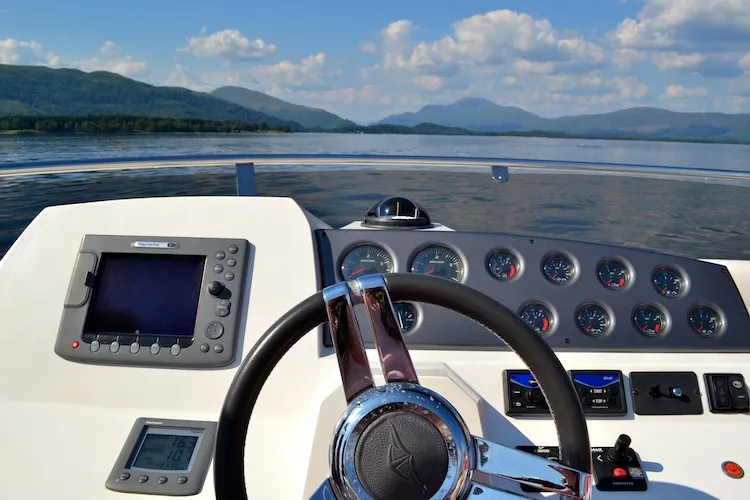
[{"left": 316, "top": 229, "right": 750, "bottom": 352}]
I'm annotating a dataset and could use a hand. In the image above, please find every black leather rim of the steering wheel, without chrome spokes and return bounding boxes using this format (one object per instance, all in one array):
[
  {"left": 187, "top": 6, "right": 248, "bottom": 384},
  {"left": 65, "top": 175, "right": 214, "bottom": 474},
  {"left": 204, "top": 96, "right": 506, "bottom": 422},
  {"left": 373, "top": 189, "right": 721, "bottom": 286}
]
[{"left": 214, "top": 273, "right": 592, "bottom": 500}]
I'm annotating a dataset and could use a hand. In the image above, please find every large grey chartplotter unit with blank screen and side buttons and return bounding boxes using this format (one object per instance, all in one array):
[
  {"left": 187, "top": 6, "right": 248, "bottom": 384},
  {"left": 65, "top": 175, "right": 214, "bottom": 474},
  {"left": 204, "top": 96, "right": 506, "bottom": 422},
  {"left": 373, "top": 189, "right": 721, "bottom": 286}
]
[{"left": 55, "top": 235, "right": 250, "bottom": 368}]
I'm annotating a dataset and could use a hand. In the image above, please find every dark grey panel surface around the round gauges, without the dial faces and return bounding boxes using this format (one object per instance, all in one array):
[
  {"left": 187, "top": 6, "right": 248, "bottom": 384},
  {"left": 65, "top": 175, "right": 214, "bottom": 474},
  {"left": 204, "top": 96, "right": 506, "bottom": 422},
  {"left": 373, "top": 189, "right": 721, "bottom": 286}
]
[{"left": 316, "top": 229, "right": 750, "bottom": 352}]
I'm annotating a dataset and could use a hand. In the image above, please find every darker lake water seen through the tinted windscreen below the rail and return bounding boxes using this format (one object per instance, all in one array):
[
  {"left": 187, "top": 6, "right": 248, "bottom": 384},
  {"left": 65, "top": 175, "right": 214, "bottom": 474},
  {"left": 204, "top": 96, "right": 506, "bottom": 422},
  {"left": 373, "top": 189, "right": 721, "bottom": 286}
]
[{"left": 0, "top": 168, "right": 750, "bottom": 259}]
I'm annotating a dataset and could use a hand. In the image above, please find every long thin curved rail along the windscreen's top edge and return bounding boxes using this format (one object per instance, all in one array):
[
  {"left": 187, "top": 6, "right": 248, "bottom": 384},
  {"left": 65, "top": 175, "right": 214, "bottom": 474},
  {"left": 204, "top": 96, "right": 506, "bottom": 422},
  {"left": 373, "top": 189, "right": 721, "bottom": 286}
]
[{"left": 0, "top": 154, "right": 750, "bottom": 185}]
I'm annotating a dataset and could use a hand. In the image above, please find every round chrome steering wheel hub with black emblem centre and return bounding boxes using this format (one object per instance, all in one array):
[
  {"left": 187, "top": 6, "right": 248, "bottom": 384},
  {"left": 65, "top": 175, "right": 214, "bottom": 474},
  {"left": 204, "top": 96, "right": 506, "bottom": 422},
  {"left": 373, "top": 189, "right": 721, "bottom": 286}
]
[{"left": 331, "top": 383, "right": 473, "bottom": 499}]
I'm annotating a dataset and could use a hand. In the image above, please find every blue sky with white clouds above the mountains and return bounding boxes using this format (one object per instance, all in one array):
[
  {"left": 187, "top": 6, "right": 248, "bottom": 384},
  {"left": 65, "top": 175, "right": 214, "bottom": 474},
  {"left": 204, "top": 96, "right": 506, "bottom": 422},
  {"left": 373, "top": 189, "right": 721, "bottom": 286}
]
[{"left": 0, "top": 0, "right": 750, "bottom": 123}]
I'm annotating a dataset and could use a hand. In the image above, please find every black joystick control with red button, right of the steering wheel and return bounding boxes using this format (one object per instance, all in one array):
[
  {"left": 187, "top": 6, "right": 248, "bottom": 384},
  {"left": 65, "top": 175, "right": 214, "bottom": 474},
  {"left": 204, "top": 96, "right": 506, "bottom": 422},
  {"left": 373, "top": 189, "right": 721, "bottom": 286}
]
[{"left": 591, "top": 434, "right": 648, "bottom": 491}]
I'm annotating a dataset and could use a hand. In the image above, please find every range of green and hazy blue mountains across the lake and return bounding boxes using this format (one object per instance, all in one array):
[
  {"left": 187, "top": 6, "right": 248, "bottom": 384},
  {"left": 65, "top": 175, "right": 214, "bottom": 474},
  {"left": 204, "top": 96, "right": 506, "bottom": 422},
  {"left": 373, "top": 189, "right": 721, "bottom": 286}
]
[{"left": 0, "top": 64, "right": 750, "bottom": 142}]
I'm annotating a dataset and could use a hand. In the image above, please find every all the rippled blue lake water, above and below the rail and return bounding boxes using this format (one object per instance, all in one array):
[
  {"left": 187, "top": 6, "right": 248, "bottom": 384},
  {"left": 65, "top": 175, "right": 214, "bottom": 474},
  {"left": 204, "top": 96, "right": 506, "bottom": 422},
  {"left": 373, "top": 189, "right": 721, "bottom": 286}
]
[{"left": 0, "top": 134, "right": 750, "bottom": 258}]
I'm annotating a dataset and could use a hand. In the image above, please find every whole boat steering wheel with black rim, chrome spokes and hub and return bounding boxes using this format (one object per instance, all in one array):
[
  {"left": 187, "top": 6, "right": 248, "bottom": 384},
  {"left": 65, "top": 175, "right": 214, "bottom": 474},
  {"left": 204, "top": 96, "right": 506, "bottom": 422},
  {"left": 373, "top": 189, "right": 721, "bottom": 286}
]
[{"left": 214, "top": 274, "right": 591, "bottom": 500}]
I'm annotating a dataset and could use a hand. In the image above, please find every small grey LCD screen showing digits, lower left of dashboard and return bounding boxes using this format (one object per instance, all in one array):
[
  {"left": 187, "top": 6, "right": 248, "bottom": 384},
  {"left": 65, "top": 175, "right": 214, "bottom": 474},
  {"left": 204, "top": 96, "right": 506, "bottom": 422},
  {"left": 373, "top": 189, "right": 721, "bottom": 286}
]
[{"left": 130, "top": 426, "right": 203, "bottom": 472}]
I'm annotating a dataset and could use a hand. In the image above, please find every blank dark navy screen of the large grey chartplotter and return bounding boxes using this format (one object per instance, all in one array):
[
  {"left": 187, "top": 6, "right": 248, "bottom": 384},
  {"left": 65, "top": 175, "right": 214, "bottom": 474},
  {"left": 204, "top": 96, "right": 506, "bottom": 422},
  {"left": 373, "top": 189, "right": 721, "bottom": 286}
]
[{"left": 83, "top": 253, "right": 206, "bottom": 336}]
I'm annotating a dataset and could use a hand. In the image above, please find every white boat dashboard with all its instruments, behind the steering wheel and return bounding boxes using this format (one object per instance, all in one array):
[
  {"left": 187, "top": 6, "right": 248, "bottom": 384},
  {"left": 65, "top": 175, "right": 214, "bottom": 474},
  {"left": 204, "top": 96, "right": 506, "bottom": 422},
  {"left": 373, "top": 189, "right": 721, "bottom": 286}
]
[{"left": 0, "top": 192, "right": 750, "bottom": 500}]
